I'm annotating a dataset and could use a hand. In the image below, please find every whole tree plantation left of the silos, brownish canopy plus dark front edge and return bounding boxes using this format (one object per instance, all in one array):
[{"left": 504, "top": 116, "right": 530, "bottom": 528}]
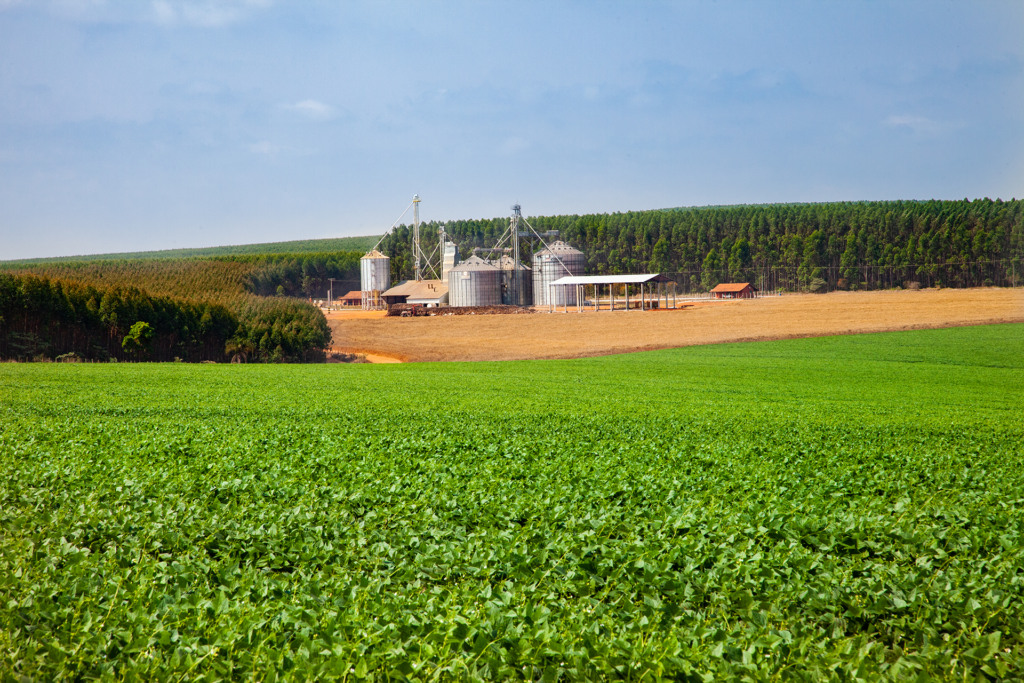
[{"left": 0, "top": 252, "right": 359, "bottom": 361}]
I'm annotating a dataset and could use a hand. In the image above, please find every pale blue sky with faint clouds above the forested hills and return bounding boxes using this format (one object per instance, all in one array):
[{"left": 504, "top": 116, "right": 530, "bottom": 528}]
[{"left": 0, "top": 0, "right": 1024, "bottom": 260}]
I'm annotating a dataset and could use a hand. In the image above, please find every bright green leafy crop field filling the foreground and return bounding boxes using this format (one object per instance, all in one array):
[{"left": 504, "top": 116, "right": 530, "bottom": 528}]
[{"left": 0, "top": 325, "right": 1024, "bottom": 681}]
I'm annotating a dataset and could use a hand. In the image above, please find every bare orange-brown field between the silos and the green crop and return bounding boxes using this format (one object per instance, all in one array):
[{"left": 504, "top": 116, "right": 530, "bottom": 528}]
[{"left": 328, "top": 288, "right": 1024, "bottom": 362}]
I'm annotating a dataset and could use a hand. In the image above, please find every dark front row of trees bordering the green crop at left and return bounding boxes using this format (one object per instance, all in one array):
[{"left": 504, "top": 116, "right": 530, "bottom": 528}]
[{"left": 0, "top": 272, "right": 331, "bottom": 362}]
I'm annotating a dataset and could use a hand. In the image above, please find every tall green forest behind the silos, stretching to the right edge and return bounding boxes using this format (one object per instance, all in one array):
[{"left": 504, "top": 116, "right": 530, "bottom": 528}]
[{"left": 382, "top": 199, "right": 1024, "bottom": 292}]
